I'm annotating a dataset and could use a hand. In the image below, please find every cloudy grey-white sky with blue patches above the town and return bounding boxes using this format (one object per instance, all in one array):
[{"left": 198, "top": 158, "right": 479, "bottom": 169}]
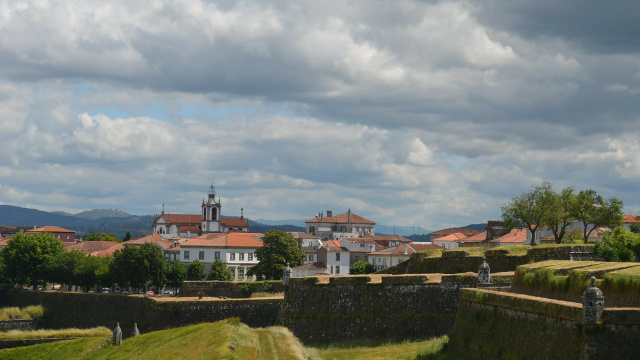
[{"left": 0, "top": 0, "right": 640, "bottom": 230}]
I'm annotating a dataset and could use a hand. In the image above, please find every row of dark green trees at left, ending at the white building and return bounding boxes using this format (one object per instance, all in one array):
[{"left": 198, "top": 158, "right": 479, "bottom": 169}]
[{"left": 0, "top": 233, "right": 225, "bottom": 291}]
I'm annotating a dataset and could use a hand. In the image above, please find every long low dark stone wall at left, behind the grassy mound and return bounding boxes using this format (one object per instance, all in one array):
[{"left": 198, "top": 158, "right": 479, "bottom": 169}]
[{"left": 0, "top": 289, "right": 282, "bottom": 336}]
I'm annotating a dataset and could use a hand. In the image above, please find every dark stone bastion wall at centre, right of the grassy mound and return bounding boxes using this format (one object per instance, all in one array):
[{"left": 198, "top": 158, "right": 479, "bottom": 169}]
[{"left": 278, "top": 277, "right": 474, "bottom": 345}]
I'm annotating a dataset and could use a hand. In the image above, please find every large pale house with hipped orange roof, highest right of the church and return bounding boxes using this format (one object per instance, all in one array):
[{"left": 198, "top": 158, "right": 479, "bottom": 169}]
[{"left": 305, "top": 209, "right": 376, "bottom": 239}]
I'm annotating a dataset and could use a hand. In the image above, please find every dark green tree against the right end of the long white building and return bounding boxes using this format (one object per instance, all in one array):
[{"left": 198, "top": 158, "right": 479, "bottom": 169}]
[{"left": 247, "top": 230, "right": 305, "bottom": 279}]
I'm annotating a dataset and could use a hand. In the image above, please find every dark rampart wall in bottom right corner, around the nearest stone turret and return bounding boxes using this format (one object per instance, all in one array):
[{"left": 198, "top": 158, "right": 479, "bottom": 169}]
[{"left": 449, "top": 289, "right": 640, "bottom": 359}]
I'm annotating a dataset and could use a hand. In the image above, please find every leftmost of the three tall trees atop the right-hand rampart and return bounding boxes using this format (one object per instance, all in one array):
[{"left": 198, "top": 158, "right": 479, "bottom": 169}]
[{"left": 502, "top": 181, "right": 554, "bottom": 245}]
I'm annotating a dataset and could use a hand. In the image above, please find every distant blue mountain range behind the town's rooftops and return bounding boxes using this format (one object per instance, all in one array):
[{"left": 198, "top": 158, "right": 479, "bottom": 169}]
[{"left": 0, "top": 205, "right": 486, "bottom": 241}]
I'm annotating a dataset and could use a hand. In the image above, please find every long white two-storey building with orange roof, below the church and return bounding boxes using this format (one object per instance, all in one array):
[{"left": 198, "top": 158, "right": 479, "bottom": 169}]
[{"left": 180, "top": 232, "right": 263, "bottom": 281}]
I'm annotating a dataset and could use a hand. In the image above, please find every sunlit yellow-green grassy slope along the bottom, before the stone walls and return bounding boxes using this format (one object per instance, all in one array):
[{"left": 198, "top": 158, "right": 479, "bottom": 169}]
[{"left": 0, "top": 320, "right": 447, "bottom": 360}]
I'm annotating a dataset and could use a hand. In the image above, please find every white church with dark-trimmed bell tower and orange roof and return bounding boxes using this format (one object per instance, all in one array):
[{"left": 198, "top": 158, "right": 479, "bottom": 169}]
[{"left": 153, "top": 184, "right": 249, "bottom": 238}]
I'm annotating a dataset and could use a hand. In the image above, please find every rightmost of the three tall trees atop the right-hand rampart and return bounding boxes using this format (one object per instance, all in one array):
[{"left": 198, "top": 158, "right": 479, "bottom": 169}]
[{"left": 571, "top": 190, "right": 624, "bottom": 243}]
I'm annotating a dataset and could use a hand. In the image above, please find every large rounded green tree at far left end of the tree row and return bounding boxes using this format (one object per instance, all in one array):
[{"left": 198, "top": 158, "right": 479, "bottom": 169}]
[{"left": 0, "top": 233, "right": 64, "bottom": 290}]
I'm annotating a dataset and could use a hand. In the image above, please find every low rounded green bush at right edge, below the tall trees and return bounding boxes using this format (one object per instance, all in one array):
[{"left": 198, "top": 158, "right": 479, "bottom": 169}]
[{"left": 593, "top": 227, "right": 640, "bottom": 261}]
